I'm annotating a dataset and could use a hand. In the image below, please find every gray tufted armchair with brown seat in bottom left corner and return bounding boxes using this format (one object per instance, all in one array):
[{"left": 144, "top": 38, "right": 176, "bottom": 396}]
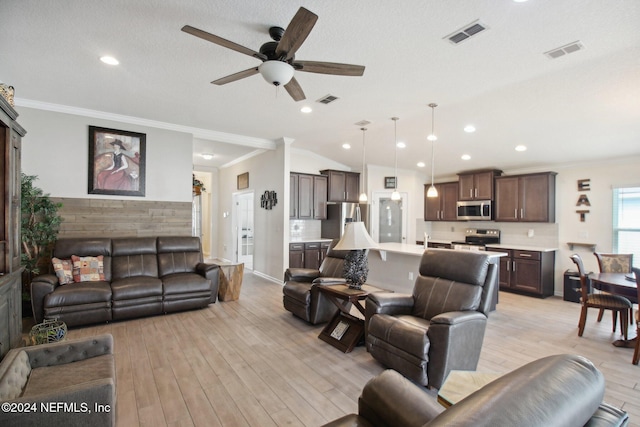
[{"left": 0, "top": 334, "right": 116, "bottom": 427}]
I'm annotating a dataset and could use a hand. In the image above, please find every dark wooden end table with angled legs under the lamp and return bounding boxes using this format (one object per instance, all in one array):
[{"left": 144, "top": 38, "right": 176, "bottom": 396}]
[{"left": 318, "top": 285, "right": 389, "bottom": 353}]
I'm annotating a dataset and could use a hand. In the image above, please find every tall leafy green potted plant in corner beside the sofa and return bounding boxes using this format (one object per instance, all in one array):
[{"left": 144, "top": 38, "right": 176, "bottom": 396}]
[{"left": 20, "top": 173, "right": 62, "bottom": 315}]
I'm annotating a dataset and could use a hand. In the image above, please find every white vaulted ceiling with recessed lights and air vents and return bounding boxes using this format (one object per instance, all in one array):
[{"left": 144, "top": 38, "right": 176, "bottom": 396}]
[{"left": 0, "top": 0, "right": 640, "bottom": 177}]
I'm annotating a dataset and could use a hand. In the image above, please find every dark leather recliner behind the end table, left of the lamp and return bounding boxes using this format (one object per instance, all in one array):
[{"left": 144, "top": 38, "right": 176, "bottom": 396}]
[{"left": 282, "top": 239, "right": 349, "bottom": 325}]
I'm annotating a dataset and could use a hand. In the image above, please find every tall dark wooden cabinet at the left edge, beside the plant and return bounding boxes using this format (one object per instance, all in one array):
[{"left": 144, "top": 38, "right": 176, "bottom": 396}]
[{"left": 0, "top": 96, "right": 26, "bottom": 359}]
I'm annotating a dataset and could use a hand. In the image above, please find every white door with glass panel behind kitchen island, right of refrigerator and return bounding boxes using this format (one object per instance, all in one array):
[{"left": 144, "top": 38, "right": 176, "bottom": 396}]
[{"left": 370, "top": 191, "right": 409, "bottom": 243}]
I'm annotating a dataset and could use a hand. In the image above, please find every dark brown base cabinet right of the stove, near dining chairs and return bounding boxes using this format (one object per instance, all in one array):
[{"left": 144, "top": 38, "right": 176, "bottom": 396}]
[{"left": 487, "top": 247, "right": 555, "bottom": 298}]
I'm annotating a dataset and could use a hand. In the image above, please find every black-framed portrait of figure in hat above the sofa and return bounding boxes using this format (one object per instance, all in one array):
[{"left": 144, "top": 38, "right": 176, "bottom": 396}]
[{"left": 89, "top": 126, "right": 147, "bottom": 197}]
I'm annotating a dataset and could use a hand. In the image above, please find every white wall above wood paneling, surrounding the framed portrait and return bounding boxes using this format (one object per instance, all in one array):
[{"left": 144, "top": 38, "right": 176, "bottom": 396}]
[{"left": 17, "top": 107, "right": 193, "bottom": 202}]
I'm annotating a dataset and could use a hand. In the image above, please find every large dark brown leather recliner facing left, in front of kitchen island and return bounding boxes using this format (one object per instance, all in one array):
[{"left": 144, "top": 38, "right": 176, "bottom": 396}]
[{"left": 365, "top": 249, "right": 498, "bottom": 389}]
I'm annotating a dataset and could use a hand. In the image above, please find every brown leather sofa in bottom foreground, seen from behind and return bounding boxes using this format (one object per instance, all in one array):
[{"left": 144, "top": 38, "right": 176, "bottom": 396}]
[{"left": 324, "top": 354, "right": 629, "bottom": 427}]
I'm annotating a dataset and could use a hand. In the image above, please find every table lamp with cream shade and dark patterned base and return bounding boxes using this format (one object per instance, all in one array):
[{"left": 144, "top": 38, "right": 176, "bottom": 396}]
[{"left": 334, "top": 221, "right": 378, "bottom": 289}]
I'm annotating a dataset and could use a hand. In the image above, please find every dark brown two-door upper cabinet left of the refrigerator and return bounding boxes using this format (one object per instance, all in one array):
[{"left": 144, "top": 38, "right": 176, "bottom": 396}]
[{"left": 289, "top": 173, "right": 327, "bottom": 219}]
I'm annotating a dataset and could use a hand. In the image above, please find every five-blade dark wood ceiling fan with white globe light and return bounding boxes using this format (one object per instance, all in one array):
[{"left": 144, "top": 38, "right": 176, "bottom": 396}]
[{"left": 182, "top": 7, "right": 364, "bottom": 101}]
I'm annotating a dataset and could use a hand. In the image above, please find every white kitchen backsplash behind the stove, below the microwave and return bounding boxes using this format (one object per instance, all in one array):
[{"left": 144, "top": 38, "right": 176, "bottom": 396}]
[{"left": 416, "top": 221, "right": 558, "bottom": 248}]
